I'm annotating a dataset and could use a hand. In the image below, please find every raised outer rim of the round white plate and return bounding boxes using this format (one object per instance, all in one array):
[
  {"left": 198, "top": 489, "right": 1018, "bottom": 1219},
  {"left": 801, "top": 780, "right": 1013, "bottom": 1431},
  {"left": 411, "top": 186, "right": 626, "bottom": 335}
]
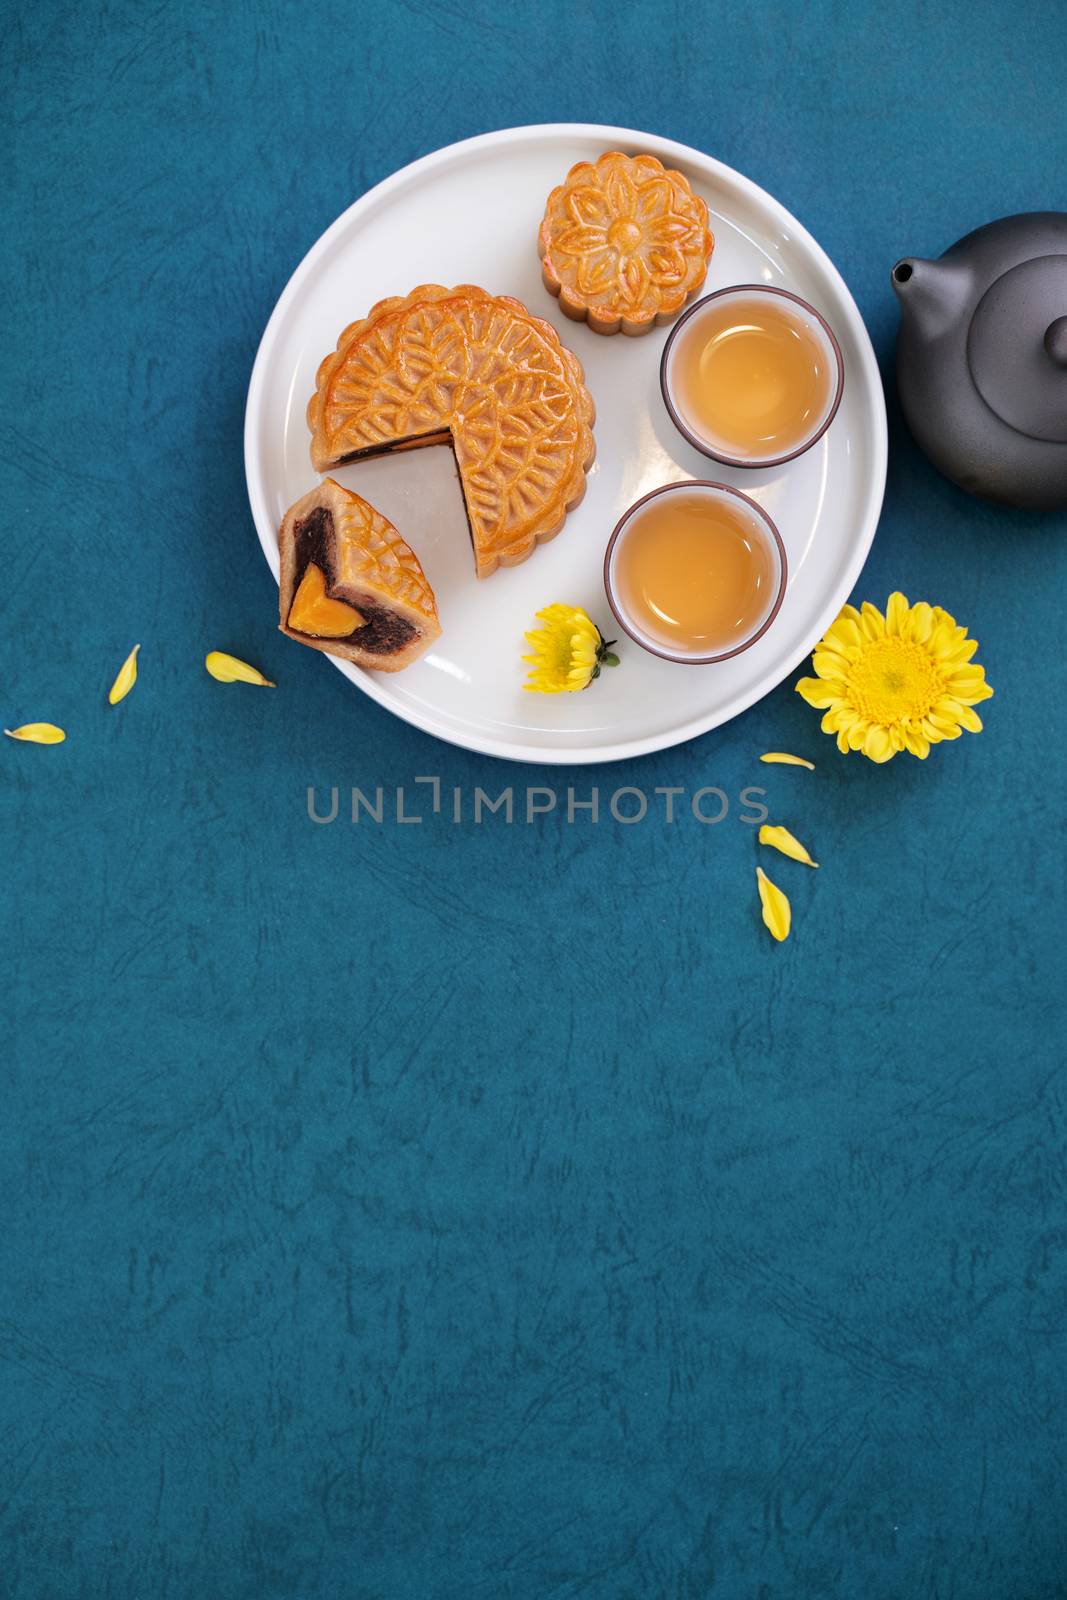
[{"left": 243, "top": 122, "right": 889, "bottom": 766}]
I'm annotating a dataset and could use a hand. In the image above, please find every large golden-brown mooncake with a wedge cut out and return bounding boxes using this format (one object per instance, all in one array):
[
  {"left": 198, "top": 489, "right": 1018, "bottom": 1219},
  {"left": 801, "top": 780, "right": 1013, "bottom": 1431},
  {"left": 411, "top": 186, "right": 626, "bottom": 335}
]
[{"left": 307, "top": 283, "right": 595, "bottom": 578}]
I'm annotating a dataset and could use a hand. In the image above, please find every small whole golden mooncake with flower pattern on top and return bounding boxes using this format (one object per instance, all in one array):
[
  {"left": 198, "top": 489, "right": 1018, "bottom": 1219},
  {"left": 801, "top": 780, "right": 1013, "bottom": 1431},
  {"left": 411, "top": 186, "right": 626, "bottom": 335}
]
[{"left": 537, "top": 150, "right": 715, "bottom": 334}]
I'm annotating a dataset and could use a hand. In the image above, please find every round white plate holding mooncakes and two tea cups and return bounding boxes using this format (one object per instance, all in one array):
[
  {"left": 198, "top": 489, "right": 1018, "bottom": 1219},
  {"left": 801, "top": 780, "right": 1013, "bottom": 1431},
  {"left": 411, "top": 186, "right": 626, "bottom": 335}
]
[{"left": 245, "top": 123, "right": 886, "bottom": 765}]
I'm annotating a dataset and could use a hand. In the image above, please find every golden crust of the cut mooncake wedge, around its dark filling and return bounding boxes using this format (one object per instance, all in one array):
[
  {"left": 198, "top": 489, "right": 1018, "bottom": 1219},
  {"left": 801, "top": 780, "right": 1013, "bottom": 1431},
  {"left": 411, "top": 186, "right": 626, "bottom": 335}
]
[{"left": 278, "top": 478, "right": 442, "bottom": 672}]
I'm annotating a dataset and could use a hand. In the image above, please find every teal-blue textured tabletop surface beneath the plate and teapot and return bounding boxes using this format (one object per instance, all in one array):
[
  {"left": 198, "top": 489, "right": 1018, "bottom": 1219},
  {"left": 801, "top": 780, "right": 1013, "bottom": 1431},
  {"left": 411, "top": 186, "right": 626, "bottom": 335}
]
[{"left": 0, "top": 0, "right": 1067, "bottom": 1600}]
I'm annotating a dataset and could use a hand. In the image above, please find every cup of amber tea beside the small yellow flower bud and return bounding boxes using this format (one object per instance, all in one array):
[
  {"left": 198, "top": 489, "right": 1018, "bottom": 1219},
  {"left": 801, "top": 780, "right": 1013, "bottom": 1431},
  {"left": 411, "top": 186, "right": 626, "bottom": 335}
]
[{"left": 605, "top": 483, "right": 785, "bottom": 664}]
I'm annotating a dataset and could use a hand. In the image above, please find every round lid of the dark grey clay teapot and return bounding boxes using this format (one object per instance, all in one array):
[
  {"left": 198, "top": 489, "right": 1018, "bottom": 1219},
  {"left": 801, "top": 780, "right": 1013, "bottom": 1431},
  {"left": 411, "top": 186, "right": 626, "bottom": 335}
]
[{"left": 966, "top": 256, "right": 1067, "bottom": 445}]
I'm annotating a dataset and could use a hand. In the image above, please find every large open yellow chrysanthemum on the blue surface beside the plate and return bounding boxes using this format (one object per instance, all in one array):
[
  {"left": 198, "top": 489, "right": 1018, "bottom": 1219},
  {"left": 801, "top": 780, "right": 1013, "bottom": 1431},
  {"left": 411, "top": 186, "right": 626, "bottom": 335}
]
[{"left": 797, "top": 594, "right": 993, "bottom": 762}]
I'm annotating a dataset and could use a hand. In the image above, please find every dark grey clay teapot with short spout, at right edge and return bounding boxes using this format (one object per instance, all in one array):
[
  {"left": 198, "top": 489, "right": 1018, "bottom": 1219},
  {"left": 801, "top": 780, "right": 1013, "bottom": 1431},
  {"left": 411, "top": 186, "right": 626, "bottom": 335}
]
[{"left": 893, "top": 211, "right": 1067, "bottom": 510}]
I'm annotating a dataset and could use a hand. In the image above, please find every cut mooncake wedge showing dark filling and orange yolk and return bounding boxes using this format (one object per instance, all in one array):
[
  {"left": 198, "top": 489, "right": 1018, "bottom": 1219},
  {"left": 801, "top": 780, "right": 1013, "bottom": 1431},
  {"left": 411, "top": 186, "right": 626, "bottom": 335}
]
[{"left": 278, "top": 478, "right": 442, "bottom": 672}]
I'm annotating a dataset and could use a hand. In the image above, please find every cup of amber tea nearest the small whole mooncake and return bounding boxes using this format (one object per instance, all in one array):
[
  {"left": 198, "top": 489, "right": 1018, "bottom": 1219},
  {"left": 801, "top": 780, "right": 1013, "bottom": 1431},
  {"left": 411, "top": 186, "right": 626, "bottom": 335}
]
[{"left": 661, "top": 285, "right": 841, "bottom": 467}]
